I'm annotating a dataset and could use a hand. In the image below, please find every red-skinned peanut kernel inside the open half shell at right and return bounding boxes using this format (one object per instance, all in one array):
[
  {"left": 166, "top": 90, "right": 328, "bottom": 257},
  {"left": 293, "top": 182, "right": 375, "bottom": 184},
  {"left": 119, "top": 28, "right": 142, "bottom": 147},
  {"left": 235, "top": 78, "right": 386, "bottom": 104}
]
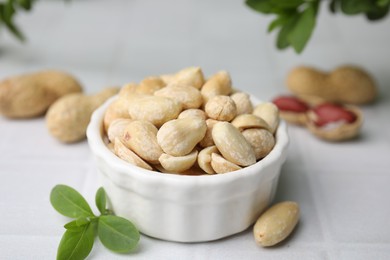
[{"left": 312, "top": 103, "right": 357, "bottom": 126}]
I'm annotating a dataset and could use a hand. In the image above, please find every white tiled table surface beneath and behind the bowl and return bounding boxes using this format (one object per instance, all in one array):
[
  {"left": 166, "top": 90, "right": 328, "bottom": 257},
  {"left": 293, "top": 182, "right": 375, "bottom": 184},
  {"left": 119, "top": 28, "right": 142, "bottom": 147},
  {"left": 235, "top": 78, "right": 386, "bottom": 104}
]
[{"left": 0, "top": 0, "right": 390, "bottom": 259}]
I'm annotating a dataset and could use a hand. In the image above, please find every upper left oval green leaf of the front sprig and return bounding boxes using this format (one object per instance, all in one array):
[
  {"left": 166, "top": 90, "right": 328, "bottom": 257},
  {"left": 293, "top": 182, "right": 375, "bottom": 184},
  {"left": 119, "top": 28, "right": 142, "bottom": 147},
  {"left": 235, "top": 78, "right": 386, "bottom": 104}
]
[{"left": 50, "top": 185, "right": 94, "bottom": 218}]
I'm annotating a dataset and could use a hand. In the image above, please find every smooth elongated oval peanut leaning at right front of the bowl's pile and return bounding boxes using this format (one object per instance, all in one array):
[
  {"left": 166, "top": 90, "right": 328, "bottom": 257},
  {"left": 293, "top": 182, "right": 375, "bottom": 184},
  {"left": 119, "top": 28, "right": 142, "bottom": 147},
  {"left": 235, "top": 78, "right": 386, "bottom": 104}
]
[{"left": 212, "top": 122, "right": 256, "bottom": 166}]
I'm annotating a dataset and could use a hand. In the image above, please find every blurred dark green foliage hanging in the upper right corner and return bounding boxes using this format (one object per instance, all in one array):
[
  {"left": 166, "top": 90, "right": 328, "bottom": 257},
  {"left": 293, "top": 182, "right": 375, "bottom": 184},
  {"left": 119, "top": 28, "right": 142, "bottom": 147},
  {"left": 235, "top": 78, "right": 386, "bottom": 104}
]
[{"left": 246, "top": 0, "right": 390, "bottom": 53}]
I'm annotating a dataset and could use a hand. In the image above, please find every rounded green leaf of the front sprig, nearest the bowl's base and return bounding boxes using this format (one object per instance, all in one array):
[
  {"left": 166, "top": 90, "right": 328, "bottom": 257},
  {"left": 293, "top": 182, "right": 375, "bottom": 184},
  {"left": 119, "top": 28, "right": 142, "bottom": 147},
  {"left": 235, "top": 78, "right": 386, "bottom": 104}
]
[{"left": 98, "top": 215, "right": 140, "bottom": 253}]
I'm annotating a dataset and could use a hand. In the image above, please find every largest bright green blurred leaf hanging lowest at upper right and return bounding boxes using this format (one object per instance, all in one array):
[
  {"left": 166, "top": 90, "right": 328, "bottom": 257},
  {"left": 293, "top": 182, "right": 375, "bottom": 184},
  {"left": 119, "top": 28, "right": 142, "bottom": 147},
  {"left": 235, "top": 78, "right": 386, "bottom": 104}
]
[{"left": 287, "top": 5, "right": 316, "bottom": 53}]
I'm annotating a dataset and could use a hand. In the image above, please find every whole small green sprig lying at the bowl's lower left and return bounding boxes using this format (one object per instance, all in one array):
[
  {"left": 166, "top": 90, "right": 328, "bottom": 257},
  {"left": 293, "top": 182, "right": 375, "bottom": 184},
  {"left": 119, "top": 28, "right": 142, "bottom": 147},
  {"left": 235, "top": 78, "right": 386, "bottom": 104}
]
[{"left": 50, "top": 185, "right": 140, "bottom": 260}]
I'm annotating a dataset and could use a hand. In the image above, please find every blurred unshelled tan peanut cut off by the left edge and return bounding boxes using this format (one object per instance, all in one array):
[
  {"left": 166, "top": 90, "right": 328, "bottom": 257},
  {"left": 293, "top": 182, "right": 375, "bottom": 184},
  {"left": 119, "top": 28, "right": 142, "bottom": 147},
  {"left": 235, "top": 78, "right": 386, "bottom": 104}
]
[{"left": 0, "top": 70, "right": 82, "bottom": 118}]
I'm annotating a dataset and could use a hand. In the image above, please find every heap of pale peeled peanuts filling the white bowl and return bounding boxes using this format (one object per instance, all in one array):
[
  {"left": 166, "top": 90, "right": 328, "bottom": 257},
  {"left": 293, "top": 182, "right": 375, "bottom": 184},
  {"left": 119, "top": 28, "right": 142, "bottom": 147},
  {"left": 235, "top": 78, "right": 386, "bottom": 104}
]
[{"left": 103, "top": 67, "right": 279, "bottom": 175}]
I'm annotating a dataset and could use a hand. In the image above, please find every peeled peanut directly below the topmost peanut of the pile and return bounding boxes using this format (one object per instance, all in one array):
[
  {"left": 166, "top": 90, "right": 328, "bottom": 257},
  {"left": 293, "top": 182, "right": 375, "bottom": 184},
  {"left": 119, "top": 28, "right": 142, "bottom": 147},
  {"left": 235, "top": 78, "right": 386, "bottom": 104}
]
[{"left": 154, "top": 84, "right": 203, "bottom": 109}]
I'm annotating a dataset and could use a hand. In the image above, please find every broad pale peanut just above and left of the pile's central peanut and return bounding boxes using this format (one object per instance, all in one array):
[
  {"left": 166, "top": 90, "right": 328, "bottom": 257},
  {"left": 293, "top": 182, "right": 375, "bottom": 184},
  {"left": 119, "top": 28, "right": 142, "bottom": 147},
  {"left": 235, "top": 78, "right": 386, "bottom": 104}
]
[{"left": 128, "top": 96, "right": 182, "bottom": 127}]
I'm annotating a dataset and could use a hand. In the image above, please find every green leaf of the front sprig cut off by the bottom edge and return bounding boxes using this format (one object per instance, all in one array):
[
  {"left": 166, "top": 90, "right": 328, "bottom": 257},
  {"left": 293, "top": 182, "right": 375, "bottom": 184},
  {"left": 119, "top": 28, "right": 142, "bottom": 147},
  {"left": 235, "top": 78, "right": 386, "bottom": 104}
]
[{"left": 57, "top": 221, "right": 95, "bottom": 260}]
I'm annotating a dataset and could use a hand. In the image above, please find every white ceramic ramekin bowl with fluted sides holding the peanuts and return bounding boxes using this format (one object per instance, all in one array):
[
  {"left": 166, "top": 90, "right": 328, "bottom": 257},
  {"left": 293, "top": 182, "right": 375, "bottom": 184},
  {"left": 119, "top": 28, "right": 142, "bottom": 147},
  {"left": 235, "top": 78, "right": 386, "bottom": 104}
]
[{"left": 87, "top": 97, "right": 288, "bottom": 242}]
